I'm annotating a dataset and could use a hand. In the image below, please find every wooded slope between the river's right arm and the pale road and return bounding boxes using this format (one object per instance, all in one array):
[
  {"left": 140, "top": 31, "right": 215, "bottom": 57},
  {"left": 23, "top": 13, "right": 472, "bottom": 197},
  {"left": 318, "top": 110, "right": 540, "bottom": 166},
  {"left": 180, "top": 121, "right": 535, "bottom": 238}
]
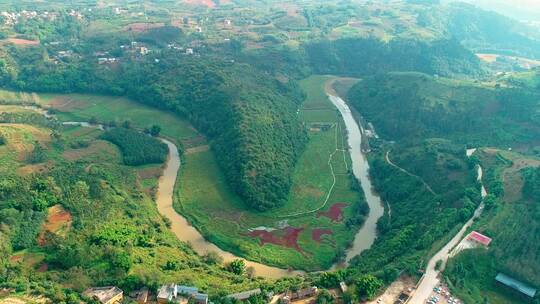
[{"left": 344, "top": 140, "right": 480, "bottom": 284}]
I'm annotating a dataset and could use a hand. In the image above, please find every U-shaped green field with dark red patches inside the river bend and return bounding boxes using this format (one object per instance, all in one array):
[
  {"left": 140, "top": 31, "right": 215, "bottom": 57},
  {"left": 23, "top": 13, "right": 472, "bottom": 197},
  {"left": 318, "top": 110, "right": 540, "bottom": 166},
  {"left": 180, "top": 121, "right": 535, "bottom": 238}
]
[{"left": 175, "top": 76, "right": 365, "bottom": 270}]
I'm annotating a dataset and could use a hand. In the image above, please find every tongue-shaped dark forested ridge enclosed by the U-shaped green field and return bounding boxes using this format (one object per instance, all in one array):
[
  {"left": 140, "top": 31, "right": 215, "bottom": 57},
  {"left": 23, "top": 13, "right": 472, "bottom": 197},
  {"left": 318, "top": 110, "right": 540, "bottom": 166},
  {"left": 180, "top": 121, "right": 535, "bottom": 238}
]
[{"left": 0, "top": 49, "right": 306, "bottom": 210}]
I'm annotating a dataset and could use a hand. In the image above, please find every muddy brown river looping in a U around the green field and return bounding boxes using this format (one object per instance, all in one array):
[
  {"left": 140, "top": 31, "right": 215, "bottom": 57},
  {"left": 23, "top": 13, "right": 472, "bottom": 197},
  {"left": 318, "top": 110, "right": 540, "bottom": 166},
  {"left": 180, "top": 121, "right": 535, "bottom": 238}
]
[{"left": 14, "top": 82, "right": 384, "bottom": 278}]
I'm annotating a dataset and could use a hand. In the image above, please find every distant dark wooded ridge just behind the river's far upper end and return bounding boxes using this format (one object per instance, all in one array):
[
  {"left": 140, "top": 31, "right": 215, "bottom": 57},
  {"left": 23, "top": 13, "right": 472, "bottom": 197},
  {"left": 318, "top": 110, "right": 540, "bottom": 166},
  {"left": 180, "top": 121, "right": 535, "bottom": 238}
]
[{"left": 305, "top": 38, "right": 482, "bottom": 77}]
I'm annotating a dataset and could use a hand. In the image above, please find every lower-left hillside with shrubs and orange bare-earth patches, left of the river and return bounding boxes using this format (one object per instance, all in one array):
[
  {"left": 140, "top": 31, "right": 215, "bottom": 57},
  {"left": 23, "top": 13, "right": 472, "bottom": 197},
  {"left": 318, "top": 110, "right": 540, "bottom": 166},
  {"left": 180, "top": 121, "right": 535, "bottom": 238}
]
[{"left": 0, "top": 108, "right": 266, "bottom": 303}]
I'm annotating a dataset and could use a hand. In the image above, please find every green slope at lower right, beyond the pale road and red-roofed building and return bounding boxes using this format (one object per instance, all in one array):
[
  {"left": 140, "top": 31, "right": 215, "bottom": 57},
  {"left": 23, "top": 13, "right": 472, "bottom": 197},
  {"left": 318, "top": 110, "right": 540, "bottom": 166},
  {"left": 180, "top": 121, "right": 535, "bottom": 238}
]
[{"left": 445, "top": 149, "right": 540, "bottom": 303}]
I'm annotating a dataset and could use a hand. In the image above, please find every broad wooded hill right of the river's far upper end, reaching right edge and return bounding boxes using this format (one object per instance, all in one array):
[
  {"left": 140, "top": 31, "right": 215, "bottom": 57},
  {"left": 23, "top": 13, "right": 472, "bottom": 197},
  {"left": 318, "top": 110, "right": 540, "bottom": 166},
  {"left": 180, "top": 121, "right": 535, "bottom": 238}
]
[{"left": 348, "top": 73, "right": 540, "bottom": 146}]
